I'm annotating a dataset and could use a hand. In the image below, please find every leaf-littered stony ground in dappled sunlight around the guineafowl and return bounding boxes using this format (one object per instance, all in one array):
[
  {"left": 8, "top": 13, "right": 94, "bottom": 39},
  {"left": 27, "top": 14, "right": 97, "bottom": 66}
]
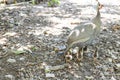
[{"left": 0, "top": 0, "right": 120, "bottom": 80}]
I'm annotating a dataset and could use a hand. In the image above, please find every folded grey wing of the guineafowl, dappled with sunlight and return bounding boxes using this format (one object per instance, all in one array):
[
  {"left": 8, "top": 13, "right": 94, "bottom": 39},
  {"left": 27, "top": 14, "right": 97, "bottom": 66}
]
[{"left": 67, "top": 23, "right": 96, "bottom": 44}]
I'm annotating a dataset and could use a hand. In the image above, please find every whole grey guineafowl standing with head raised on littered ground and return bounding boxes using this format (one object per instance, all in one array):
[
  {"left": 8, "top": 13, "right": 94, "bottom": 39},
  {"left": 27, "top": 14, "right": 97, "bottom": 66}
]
[{"left": 65, "top": 0, "right": 103, "bottom": 61}]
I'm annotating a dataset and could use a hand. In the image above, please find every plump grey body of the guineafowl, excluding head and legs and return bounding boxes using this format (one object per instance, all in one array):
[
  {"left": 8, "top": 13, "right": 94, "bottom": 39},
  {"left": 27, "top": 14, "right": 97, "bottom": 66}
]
[{"left": 67, "top": 13, "right": 101, "bottom": 50}]
